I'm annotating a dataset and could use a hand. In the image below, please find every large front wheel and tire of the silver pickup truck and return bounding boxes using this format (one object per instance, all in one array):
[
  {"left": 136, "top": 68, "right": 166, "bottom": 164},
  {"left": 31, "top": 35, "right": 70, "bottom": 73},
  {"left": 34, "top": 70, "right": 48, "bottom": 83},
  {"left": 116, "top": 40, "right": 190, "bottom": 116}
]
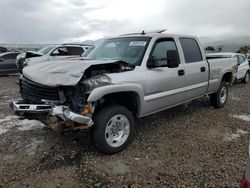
[{"left": 91, "top": 105, "right": 135, "bottom": 154}]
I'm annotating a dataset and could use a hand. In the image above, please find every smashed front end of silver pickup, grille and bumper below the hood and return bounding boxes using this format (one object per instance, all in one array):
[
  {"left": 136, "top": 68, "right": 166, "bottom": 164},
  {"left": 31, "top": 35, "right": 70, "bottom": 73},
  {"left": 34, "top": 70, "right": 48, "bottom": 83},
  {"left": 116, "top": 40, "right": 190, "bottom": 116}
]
[{"left": 10, "top": 77, "right": 93, "bottom": 130}]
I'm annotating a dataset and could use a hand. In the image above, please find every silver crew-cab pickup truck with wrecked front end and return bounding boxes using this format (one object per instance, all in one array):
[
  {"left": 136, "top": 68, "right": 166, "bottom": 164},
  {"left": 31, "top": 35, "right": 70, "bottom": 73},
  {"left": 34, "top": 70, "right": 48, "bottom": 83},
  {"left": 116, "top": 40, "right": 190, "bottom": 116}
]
[{"left": 10, "top": 32, "right": 237, "bottom": 154}]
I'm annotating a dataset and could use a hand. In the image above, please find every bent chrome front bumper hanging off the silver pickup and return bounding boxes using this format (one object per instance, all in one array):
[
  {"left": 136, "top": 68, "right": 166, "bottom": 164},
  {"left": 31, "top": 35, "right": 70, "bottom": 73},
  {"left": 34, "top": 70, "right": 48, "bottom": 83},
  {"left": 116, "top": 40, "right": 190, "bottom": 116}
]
[{"left": 10, "top": 101, "right": 94, "bottom": 127}]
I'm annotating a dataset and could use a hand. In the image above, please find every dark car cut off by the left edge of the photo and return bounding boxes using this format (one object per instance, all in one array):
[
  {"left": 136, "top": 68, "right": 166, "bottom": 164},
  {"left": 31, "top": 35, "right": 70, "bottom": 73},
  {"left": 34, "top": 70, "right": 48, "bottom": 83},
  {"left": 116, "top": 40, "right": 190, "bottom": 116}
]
[{"left": 0, "top": 52, "right": 20, "bottom": 75}]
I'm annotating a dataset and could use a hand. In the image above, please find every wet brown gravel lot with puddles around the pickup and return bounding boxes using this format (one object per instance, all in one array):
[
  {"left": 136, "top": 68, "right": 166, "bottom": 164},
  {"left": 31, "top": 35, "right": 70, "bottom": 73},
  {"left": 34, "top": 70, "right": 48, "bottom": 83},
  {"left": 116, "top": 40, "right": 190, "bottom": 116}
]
[{"left": 0, "top": 76, "right": 250, "bottom": 187}]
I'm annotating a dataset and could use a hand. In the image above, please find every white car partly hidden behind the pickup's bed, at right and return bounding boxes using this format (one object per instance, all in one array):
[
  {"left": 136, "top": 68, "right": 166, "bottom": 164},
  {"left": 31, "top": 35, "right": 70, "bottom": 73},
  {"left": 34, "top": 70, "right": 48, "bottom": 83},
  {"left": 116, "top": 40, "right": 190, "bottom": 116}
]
[{"left": 206, "top": 52, "right": 250, "bottom": 83}]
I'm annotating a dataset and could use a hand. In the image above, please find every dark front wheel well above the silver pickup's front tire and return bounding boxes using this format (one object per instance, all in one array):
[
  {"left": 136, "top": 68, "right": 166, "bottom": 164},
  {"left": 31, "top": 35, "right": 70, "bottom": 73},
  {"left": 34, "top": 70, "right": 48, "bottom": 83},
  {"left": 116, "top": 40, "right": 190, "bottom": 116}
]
[{"left": 95, "top": 91, "right": 140, "bottom": 117}]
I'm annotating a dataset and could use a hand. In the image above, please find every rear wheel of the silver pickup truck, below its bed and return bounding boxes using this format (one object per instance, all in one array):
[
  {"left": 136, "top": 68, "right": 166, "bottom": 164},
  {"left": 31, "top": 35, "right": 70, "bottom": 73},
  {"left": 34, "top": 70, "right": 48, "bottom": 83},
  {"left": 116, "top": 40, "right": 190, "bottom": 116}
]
[{"left": 210, "top": 81, "right": 228, "bottom": 108}]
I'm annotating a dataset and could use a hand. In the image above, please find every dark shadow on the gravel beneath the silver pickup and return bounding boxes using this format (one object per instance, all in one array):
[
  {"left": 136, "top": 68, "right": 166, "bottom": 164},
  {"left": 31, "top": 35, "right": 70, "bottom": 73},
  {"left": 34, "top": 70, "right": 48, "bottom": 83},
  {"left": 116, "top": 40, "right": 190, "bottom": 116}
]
[{"left": 46, "top": 97, "right": 212, "bottom": 156}]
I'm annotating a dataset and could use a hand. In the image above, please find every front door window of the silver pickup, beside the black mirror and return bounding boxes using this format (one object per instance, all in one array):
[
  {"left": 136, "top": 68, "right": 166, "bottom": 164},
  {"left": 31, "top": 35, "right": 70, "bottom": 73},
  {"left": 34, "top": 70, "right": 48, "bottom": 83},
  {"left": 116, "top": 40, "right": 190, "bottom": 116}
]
[{"left": 151, "top": 39, "right": 177, "bottom": 66}]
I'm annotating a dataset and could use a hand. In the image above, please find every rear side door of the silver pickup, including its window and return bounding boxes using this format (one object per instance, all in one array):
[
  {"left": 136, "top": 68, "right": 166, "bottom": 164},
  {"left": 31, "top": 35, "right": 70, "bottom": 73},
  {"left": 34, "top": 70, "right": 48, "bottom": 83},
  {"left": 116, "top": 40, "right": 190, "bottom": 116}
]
[{"left": 179, "top": 37, "right": 209, "bottom": 99}]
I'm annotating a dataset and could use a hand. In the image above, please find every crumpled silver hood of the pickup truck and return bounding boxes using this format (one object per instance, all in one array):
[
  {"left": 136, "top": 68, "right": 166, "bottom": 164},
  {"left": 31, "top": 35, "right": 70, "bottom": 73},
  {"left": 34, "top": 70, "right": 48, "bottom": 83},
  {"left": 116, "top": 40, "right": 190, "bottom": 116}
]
[{"left": 23, "top": 60, "right": 121, "bottom": 86}]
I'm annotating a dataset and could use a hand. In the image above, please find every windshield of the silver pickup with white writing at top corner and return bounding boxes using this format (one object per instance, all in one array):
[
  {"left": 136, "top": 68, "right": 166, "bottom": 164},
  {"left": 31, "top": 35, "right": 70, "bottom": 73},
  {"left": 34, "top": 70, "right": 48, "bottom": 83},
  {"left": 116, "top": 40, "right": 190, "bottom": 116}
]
[{"left": 87, "top": 37, "right": 151, "bottom": 66}]
